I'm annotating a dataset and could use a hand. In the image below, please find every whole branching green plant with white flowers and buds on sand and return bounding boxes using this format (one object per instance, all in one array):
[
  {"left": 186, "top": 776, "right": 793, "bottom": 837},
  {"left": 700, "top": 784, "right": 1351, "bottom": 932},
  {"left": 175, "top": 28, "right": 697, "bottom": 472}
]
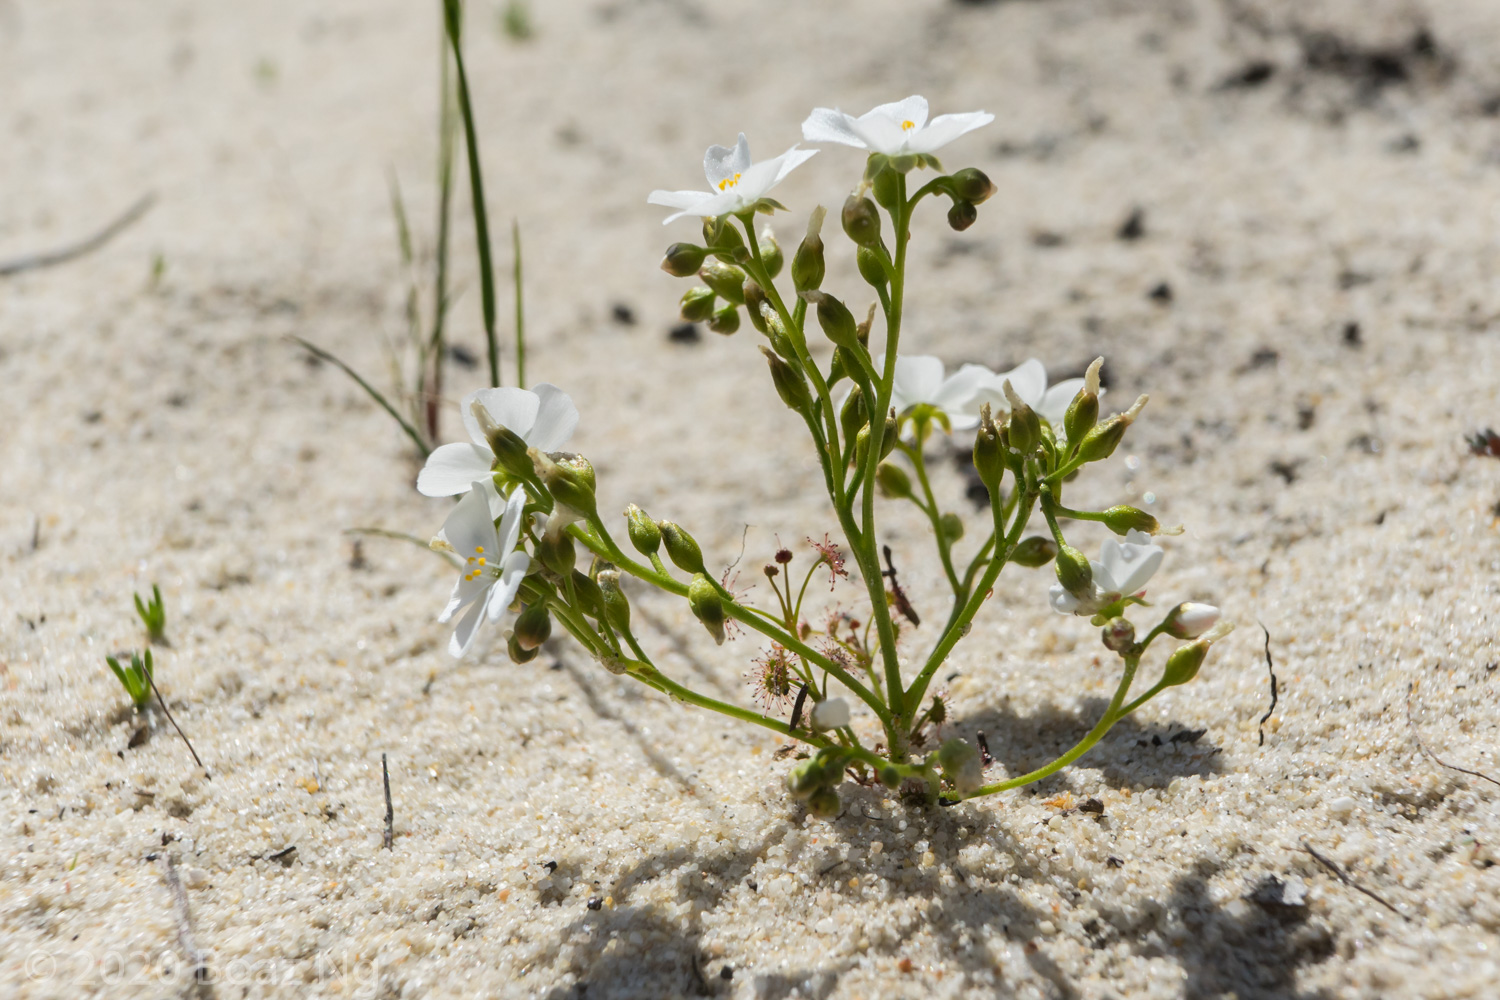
[{"left": 405, "top": 97, "right": 1230, "bottom": 817}]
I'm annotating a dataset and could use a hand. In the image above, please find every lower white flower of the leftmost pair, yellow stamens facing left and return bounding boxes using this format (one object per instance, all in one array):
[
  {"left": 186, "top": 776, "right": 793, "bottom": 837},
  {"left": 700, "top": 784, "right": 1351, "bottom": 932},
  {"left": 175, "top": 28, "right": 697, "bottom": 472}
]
[{"left": 432, "top": 477, "right": 531, "bottom": 657}]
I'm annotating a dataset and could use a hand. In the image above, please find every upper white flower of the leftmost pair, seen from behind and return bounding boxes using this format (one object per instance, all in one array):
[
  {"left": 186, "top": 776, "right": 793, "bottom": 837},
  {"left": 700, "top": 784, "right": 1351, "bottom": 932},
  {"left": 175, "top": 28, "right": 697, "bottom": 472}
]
[{"left": 417, "top": 382, "right": 578, "bottom": 496}]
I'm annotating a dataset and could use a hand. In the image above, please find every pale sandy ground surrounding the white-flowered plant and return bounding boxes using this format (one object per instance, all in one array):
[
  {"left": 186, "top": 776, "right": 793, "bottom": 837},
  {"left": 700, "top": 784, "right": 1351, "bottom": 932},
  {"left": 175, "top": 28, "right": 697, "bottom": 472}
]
[{"left": 0, "top": 0, "right": 1500, "bottom": 999}]
